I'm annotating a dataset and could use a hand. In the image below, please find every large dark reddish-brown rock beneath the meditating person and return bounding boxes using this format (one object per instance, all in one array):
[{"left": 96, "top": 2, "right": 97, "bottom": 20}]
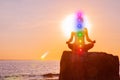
[{"left": 59, "top": 51, "right": 119, "bottom": 80}]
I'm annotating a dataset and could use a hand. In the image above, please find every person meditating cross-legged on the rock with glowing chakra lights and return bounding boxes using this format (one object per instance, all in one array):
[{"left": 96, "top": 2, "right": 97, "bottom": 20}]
[{"left": 66, "top": 13, "right": 96, "bottom": 52}]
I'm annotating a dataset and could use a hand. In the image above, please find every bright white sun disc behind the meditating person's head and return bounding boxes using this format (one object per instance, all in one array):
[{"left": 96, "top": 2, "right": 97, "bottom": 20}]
[{"left": 61, "top": 13, "right": 91, "bottom": 38}]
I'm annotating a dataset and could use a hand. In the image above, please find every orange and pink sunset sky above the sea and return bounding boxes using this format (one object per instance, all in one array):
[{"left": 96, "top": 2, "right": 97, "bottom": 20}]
[{"left": 0, "top": 0, "right": 120, "bottom": 60}]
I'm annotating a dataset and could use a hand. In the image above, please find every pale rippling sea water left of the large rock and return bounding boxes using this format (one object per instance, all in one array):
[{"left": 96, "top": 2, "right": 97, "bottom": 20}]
[{"left": 0, "top": 60, "right": 59, "bottom": 80}]
